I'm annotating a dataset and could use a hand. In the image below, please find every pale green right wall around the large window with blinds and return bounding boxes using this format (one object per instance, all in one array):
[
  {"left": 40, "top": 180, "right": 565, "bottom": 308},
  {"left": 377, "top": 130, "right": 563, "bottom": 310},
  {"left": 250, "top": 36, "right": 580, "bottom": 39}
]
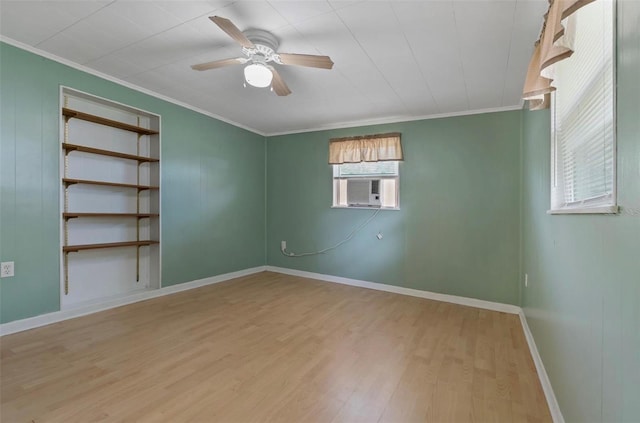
[{"left": 522, "top": 0, "right": 640, "bottom": 422}]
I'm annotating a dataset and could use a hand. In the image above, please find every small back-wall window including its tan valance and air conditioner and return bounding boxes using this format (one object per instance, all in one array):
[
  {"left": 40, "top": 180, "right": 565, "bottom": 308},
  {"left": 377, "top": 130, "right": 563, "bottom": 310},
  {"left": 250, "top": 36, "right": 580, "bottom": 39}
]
[{"left": 329, "top": 133, "right": 403, "bottom": 209}]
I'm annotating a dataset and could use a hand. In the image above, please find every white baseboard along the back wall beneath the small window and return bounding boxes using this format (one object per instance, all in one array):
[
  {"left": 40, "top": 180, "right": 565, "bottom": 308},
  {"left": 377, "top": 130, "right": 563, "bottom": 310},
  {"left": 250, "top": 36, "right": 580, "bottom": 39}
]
[{"left": 266, "top": 266, "right": 521, "bottom": 314}]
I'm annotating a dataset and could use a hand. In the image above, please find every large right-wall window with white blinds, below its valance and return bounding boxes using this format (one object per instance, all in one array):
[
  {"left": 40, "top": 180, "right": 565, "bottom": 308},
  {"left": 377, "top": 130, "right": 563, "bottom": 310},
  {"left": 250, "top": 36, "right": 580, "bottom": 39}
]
[{"left": 551, "top": 0, "right": 616, "bottom": 213}]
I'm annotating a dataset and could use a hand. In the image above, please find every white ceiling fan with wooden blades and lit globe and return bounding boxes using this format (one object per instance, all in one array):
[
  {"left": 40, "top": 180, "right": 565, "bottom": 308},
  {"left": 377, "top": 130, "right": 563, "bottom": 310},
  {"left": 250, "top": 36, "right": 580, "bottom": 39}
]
[{"left": 191, "top": 16, "right": 333, "bottom": 96}]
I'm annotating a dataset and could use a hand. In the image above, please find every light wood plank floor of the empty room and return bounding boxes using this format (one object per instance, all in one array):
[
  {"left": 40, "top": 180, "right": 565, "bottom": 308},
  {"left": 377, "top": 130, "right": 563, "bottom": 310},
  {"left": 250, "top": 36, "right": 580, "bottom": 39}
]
[{"left": 0, "top": 273, "right": 551, "bottom": 423}]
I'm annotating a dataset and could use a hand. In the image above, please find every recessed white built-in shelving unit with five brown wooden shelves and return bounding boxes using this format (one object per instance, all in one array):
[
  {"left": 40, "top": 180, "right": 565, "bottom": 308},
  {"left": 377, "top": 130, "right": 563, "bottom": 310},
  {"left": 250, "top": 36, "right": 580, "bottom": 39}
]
[{"left": 60, "top": 88, "right": 160, "bottom": 308}]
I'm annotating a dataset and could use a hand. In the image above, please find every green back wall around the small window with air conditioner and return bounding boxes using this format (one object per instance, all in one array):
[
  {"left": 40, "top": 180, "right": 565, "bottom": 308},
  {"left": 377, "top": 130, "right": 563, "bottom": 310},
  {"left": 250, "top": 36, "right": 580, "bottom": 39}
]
[{"left": 266, "top": 111, "right": 521, "bottom": 304}]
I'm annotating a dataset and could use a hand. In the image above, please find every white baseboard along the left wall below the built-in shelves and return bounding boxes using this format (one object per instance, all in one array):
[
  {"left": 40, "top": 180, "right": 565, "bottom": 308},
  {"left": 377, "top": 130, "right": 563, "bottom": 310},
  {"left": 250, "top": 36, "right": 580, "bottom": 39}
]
[{"left": 0, "top": 266, "right": 266, "bottom": 336}]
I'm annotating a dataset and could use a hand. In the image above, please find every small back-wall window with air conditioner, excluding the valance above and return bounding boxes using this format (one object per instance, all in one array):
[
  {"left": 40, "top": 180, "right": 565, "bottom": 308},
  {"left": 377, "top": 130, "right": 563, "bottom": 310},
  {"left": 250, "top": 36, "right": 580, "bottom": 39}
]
[{"left": 333, "top": 161, "right": 399, "bottom": 209}]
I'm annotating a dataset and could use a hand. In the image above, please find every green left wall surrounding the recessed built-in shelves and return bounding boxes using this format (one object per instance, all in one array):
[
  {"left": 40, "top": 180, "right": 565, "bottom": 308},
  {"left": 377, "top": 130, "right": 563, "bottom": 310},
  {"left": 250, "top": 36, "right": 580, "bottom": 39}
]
[{"left": 0, "top": 43, "right": 265, "bottom": 322}]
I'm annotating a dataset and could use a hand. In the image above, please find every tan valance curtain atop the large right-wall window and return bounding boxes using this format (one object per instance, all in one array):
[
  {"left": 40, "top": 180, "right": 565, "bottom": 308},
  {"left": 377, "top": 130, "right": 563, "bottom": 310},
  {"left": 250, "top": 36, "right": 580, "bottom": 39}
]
[{"left": 522, "top": 0, "right": 595, "bottom": 110}]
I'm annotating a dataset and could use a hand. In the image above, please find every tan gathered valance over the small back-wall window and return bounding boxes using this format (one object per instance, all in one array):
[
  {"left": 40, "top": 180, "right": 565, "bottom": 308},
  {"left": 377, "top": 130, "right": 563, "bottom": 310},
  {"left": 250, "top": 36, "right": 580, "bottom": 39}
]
[{"left": 329, "top": 132, "right": 403, "bottom": 164}]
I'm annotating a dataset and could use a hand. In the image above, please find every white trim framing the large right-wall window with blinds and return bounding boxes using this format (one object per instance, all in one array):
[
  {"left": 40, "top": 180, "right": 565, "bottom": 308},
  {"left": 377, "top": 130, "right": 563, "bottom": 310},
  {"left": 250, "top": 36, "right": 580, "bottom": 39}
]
[{"left": 547, "top": 0, "right": 620, "bottom": 215}]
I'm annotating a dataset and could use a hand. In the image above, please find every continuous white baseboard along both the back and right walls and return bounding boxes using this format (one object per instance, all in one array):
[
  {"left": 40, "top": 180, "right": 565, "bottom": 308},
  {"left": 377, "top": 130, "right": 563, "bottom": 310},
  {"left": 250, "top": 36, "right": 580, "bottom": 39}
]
[{"left": 265, "top": 266, "right": 564, "bottom": 423}]
